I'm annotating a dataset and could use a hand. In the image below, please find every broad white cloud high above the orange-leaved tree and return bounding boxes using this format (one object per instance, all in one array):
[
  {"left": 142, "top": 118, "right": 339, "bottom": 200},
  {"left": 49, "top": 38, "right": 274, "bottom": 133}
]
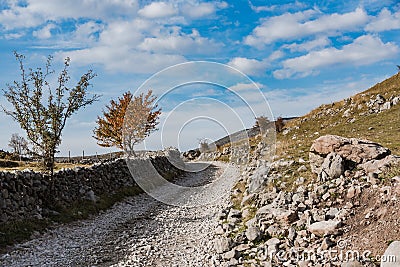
[{"left": 59, "top": 18, "right": 221, "bottom": 73}]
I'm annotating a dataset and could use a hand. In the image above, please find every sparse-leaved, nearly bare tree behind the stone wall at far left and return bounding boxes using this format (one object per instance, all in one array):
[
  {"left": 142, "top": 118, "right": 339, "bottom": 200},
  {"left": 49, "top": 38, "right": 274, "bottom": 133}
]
[{"left": 2, "top": 52, "right": 99, "bottom": 175}]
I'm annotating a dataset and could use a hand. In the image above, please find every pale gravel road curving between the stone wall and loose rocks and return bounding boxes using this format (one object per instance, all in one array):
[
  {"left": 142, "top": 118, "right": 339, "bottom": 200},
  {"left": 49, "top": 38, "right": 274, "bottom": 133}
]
[{"left": 0, "top": 163, "right": 239, "bottom": 267}]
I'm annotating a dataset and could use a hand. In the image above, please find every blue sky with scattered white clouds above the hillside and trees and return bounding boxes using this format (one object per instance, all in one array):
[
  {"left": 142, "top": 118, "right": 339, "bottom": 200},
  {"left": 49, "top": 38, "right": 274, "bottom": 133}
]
[{"left": 0, "top": 0, "right": 400, "bottom": 155}]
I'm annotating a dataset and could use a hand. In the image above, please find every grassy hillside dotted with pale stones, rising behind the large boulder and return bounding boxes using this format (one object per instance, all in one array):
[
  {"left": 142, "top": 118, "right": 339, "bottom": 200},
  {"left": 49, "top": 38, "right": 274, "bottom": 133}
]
[{"left": 277, "top": 74, "right": 400, "bottom": 159}]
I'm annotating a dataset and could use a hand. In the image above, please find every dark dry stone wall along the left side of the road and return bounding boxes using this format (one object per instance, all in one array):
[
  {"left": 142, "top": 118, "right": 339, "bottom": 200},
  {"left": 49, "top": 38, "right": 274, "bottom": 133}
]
[{"left": 0, "top": 151, "right": 182, "bottom": 222}]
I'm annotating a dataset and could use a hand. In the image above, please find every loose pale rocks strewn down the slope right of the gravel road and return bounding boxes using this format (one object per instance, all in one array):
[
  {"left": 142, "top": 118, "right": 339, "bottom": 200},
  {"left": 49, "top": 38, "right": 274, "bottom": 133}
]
[{"left": 211, "top": 136, "right": 400, "bottom": 266}]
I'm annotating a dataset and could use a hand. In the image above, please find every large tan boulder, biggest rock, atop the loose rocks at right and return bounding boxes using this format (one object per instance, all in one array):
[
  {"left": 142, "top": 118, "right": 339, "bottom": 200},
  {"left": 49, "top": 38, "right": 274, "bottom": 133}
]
[{"left": 309, "top": 135, "right": 400, "bottom": 180}]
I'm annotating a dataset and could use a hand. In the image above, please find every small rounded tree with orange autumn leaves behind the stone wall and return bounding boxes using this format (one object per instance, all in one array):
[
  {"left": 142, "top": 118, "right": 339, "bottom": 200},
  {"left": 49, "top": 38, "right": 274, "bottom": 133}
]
[{"left": 93, "top": 90, "right": 161, "bottom": 154}]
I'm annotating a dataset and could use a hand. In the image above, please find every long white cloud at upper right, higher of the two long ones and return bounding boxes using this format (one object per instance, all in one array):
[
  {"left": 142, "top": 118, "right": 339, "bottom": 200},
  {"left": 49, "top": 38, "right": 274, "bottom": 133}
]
[{"left": 244, "top": 8, "right": 368, "bottom": 47}]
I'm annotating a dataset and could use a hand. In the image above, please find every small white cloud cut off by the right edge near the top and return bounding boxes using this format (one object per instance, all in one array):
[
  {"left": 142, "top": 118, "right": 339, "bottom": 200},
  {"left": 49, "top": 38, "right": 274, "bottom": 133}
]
[{"left": 365, "top": 8, "right": 400, "bottom": 32}]
